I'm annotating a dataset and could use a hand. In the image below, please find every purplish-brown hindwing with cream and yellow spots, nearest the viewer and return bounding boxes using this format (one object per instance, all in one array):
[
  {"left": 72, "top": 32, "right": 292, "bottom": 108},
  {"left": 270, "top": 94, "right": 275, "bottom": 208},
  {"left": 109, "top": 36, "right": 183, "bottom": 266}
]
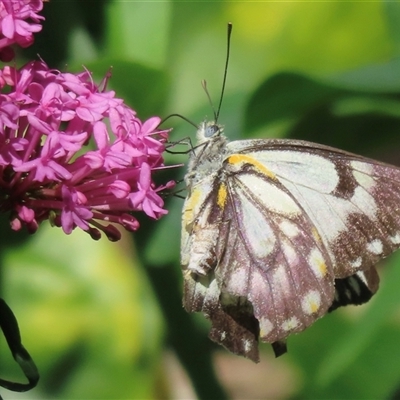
[{"left": 215, "top": 155, "right": 334, "bottom": 343}]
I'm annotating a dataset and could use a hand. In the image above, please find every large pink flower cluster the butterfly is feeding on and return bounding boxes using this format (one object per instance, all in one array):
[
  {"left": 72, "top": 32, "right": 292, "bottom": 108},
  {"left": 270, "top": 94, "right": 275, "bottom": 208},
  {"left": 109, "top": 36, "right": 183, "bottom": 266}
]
[{"left": 0, "top": 61, "right": 174, "bottom": 240}]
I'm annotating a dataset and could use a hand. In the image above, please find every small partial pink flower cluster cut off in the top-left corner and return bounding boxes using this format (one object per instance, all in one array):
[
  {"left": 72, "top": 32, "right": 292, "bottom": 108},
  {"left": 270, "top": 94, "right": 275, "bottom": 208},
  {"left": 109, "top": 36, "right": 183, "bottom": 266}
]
[{"left": 0, "top": 0, "right": 44, "bottom": 61}]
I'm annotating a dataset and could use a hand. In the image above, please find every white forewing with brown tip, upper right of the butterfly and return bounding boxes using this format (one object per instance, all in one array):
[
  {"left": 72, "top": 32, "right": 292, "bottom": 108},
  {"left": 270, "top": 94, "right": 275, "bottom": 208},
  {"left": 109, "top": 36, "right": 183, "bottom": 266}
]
[{"left": 228, "top": 140, "right": 400, "bottom": 278}]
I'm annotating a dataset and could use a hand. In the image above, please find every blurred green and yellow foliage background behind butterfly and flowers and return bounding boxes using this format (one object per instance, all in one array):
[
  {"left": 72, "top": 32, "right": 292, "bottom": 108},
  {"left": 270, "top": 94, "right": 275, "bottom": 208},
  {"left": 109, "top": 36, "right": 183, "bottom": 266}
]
[{"left": 0, "top": 0, "right": 400, "bottom": 400}]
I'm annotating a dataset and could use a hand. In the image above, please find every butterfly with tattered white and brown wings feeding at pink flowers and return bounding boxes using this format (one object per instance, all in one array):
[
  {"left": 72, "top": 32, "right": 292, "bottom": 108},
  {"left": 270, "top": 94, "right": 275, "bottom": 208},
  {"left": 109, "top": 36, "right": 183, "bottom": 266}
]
[{"left": 181, "top": 122, "right": 400, "bottom": 361}]
